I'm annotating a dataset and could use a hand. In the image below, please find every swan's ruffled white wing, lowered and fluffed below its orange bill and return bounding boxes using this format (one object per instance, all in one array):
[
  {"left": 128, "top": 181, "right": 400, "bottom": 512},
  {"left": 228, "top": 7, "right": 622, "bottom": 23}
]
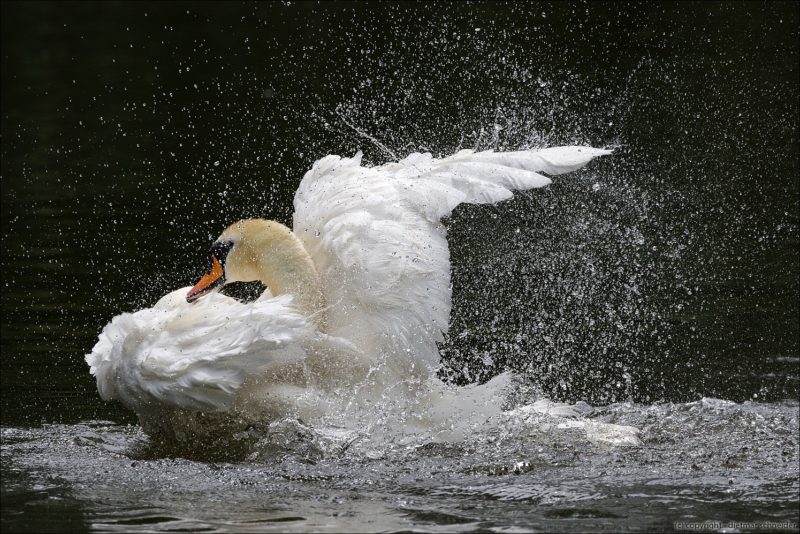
[{"left": 86, "top": 288, "right": 313, "bottom": 412}]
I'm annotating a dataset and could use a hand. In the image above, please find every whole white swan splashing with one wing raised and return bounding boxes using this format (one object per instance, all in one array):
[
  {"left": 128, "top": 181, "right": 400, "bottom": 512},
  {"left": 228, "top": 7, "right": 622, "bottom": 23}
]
[{"left": 86, "top": 146, "right": 611, "bottom": 450}]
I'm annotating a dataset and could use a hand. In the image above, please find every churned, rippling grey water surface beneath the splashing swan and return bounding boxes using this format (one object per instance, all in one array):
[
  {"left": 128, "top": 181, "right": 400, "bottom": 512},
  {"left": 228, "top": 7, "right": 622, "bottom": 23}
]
[{"left": 2, "top": 399, "right": 798, "bottom": 532}]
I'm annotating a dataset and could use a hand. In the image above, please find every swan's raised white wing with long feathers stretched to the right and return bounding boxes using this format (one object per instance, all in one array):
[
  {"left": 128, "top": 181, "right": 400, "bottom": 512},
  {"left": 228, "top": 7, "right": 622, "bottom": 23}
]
[{"left": 294, "top": 146, "right": 610, "bottom": 372}]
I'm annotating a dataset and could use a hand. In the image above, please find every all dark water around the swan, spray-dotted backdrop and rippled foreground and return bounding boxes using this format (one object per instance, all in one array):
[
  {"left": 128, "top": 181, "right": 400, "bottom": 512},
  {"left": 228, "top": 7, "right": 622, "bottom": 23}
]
[{"left": 0, "top": 3, "right": 800, "bottom": 532}]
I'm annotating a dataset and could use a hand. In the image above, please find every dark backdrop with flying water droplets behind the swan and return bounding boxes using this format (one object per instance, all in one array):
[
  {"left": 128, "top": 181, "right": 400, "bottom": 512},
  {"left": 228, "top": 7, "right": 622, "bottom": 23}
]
[{"left": 0, "top": 2, "right": 800, "bottom": 424}]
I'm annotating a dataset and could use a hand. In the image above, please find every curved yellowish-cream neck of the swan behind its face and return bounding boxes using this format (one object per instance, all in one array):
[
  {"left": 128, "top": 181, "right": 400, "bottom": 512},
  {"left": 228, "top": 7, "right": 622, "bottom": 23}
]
[{"left": 227, "top": 220, "right": 325, "bottom": 328}]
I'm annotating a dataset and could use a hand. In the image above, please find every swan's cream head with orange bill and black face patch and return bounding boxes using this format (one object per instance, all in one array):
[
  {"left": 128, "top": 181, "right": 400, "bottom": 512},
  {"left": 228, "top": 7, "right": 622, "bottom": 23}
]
[{"left": 186, "top": 219, "right": 282, "bottom": 302}]
